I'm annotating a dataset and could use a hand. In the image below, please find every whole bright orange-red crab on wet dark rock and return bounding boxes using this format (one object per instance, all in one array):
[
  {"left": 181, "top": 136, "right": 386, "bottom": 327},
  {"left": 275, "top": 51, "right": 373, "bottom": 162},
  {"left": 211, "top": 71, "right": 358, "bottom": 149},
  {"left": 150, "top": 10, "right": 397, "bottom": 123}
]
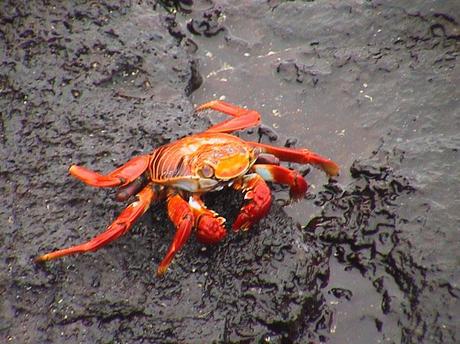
[{"left": 36, "top": 100, "right": 339, "bottom": 275}]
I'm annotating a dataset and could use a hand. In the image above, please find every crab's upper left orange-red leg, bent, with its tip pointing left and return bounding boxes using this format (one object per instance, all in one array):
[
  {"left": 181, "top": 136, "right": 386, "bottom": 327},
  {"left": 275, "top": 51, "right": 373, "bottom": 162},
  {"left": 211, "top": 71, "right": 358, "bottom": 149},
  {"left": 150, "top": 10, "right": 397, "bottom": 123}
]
[{"left": 69, "top": 155, "right": 150, "bottom": 187}]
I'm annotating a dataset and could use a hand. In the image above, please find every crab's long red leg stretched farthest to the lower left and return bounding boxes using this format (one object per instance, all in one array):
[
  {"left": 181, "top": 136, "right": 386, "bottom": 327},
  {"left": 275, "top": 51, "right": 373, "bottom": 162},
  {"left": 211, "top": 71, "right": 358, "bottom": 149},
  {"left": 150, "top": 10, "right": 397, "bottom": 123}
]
[{"left": 35, "top": 185, "right": 157, "bottom": 262}]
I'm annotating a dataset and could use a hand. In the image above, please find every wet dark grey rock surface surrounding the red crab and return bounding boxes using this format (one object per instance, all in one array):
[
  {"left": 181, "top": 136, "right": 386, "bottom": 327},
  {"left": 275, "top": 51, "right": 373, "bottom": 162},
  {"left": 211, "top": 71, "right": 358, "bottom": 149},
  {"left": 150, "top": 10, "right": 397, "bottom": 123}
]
[{"left": 0, "top": 1, "right": 460, "bottom": 343}]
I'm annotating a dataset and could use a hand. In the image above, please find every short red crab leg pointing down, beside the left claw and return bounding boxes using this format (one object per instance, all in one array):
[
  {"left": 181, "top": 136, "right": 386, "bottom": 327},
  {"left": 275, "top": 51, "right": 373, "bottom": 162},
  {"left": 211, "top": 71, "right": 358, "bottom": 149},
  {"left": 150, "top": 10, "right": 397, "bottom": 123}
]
[{"left": 157, "top": 193, "right": 195, "bottom": 276}]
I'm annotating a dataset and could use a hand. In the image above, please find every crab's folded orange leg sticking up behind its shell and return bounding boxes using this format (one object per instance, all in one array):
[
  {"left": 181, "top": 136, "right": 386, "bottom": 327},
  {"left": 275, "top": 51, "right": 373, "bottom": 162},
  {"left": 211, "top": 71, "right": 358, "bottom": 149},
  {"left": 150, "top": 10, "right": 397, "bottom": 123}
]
[{"left": 196, "top": 100, "right": 260, "bottom": 133}]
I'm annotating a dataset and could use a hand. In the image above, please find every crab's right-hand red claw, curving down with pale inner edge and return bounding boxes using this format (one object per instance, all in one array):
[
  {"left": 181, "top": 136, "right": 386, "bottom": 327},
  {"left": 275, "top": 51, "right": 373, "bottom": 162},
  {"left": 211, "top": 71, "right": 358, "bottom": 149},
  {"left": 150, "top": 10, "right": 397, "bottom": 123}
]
[{"left": 232, "top": 173, "right": 272, "bottom": 231}]
